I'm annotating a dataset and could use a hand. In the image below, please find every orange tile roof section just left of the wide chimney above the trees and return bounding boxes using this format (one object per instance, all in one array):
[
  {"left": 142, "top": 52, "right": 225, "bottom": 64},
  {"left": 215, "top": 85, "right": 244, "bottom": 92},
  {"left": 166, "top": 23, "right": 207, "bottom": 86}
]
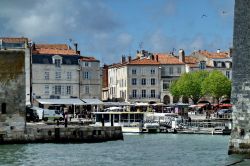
[{"left": 154, "top": 53, "right": 184, "bottom": 65}]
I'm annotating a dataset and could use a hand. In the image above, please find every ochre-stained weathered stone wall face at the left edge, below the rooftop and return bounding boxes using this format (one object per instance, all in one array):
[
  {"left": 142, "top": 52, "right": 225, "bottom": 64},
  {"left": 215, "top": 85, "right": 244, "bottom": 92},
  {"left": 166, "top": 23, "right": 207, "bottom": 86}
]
[{"left": 0, "top": 50, "right": 26, "bottom": 139}]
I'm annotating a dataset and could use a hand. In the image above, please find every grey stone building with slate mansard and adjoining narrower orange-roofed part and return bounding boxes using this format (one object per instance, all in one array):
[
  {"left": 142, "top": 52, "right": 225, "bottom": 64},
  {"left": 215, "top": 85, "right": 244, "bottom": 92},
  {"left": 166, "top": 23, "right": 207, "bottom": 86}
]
[{"left": 32, "top": 44, "right": 101, "bottom": 102}]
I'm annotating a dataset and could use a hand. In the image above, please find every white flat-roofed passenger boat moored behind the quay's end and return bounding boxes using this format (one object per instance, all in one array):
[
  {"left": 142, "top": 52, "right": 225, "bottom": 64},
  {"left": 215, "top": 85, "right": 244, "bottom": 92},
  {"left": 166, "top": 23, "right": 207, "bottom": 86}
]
[{"left": 93, "top": 111, "right": 159, "bottom": 133}]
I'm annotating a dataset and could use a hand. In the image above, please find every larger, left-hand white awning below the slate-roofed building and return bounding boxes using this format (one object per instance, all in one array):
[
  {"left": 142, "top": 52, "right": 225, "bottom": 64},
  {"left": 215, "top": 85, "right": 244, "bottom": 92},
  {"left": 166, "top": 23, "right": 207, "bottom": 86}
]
[{"left": 36, "top": 99, "right": 86, "bottom": 105}]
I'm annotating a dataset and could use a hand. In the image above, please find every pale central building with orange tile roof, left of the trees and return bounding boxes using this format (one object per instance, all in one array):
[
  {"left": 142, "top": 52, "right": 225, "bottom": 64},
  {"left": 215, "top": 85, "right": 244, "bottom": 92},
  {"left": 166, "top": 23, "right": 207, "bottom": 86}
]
[{"left": 103, "top": 50, "right": 185, "bottom": 104}]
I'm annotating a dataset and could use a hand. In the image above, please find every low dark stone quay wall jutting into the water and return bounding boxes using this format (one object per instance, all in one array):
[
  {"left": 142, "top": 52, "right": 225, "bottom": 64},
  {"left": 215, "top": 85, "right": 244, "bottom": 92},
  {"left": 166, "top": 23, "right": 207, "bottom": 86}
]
[{"left": 0, "top": 124, "right": 123, "bottom": 144}]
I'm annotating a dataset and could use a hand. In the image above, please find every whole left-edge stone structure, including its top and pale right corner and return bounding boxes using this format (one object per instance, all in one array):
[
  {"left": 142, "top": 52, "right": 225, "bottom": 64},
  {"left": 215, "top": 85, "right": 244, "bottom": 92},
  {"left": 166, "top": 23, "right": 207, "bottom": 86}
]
[{"left": 0, "top": 38, "right": 30, "bottom": 142}]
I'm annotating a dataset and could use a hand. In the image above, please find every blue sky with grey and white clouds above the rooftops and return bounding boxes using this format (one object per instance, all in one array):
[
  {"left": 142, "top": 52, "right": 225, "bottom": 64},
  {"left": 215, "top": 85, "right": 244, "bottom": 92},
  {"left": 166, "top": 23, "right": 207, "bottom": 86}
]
[{"left": 0, "top": 0, "right": 234, "bottom": 64}]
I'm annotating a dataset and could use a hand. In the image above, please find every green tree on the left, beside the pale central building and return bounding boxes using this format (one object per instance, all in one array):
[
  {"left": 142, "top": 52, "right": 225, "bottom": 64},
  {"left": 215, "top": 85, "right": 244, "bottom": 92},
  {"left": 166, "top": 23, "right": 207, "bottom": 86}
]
[{"left": 170, "top": 71, "right": 208, "bottom": 104}]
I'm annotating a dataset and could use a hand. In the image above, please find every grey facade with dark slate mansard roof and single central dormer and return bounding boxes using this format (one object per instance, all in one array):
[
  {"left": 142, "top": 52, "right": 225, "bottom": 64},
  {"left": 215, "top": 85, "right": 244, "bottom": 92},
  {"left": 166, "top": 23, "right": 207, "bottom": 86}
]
[{"left": 32, "top": 55, "right": 80, "bottom": 99}]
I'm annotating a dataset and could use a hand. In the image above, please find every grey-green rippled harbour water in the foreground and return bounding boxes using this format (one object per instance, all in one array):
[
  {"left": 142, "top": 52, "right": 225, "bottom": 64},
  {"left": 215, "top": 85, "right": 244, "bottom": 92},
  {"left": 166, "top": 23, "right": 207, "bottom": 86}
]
[{"left": 0, "top": 134, "right": 250, "bottom": 166}]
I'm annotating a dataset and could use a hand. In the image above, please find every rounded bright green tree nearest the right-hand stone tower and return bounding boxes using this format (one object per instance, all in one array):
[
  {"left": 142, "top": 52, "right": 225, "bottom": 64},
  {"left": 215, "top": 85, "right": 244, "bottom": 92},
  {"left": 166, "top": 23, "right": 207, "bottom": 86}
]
[{"left": 202, "top": 70, "right": 231, "bottom": 102}]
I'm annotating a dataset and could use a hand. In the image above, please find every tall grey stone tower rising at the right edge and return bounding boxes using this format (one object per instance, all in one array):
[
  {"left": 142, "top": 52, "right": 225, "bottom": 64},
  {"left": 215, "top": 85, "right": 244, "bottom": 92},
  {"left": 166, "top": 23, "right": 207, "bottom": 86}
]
[{"left": 228, "top": 0, "right": 250, "bottom": 154}]
